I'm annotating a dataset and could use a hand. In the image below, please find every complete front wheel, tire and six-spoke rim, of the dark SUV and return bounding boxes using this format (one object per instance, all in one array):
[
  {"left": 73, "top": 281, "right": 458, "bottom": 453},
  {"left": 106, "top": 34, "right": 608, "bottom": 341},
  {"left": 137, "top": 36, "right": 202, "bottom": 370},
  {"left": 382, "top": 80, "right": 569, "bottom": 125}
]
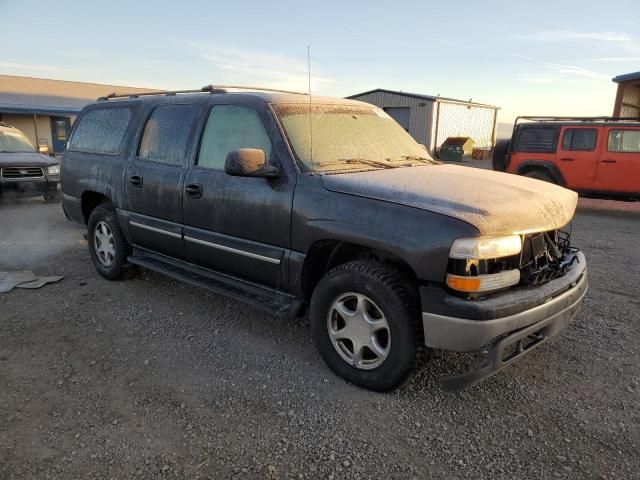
[{"left": 310, "top": 261, "right": 422, "bottom": 391}]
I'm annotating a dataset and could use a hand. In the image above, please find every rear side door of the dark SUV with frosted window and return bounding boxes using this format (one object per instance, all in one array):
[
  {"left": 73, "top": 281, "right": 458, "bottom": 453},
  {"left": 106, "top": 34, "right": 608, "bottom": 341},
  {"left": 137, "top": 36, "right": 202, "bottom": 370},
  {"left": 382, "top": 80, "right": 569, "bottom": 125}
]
[{"left": 124, "top": 103, "right": 199, "bottom": 258}]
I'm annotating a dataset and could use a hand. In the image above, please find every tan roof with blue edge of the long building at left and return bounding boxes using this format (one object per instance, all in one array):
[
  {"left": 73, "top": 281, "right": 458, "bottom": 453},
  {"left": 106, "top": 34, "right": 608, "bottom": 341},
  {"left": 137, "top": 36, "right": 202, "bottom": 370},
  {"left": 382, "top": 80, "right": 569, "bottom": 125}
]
[{"left": 0, "top": 75, "right": 159, "bottom": 115}]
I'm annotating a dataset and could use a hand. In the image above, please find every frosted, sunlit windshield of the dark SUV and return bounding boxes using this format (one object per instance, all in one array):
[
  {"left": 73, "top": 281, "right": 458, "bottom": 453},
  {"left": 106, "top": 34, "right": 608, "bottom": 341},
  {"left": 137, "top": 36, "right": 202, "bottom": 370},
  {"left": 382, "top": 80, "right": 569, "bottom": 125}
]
[{"left": 273, "top": 104, "right": 433, "bottom": 172}]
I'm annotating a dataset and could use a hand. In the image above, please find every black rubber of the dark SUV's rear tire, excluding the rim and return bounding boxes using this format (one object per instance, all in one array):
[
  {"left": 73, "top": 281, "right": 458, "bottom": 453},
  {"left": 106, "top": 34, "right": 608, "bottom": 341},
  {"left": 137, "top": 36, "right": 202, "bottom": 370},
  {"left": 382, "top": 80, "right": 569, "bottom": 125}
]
[{"left": 87, "top": 203, "right": 131, "bottom": 280}]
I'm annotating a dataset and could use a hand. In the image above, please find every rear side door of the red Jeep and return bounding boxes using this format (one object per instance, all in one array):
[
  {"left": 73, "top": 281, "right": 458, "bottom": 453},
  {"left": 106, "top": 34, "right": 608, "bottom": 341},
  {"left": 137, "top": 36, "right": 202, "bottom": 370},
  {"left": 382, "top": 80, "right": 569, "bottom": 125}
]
[{"left": 556, "top": 126, "right": 598, "bottom": 190}]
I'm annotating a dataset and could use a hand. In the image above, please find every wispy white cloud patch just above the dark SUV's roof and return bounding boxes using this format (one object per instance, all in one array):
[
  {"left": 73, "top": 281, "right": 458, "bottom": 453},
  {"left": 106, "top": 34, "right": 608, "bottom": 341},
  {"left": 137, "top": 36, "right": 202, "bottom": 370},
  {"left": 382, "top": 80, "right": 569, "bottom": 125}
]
[{"left": 191, "top": 44, "right": 333, "bottom": 92}]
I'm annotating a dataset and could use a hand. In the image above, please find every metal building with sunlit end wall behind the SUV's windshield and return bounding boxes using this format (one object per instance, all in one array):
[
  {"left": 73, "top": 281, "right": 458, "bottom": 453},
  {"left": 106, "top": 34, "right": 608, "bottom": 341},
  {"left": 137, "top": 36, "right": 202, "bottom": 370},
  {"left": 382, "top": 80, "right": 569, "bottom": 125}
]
[{"left": 347, "top": 88, "right": 499, "bottom": 154}]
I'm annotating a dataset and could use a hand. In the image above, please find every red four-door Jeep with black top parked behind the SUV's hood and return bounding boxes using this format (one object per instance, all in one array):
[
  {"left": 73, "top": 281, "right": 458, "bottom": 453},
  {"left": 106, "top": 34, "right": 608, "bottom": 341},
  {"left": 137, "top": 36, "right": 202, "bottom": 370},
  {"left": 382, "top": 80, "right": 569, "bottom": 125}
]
[{"left": 493, "top": 117, "right": 640, "bottom": 198}]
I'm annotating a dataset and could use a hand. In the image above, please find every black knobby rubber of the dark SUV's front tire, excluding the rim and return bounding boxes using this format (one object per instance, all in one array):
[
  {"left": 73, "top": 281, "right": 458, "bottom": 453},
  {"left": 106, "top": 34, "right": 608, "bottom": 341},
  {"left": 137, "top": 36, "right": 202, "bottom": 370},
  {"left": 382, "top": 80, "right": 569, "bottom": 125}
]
[{"left": 309, "top": 260, "right": 424, "bottom": 392}]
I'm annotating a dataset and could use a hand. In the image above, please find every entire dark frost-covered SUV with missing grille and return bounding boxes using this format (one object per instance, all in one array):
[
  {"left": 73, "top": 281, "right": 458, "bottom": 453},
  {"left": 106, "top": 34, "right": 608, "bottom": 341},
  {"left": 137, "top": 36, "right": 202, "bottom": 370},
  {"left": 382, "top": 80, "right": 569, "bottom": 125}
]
[{"left": 62, "top": 86, "right": 587, "bottom": 390}]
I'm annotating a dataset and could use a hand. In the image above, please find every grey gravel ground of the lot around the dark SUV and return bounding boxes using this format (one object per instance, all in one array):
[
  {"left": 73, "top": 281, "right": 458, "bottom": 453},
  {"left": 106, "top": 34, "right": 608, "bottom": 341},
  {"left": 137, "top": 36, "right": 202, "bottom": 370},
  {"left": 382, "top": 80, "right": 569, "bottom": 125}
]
[{"left": 0, "top": 199, "right": 640, "bottom": 480}]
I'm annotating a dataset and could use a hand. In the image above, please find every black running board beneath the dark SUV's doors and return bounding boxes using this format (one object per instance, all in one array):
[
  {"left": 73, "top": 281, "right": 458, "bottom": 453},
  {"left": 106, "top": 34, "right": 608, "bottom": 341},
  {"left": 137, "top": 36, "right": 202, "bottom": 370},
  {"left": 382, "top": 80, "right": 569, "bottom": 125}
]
[{"left": 127, "top": 248, "right": 303, "bottom": 318}]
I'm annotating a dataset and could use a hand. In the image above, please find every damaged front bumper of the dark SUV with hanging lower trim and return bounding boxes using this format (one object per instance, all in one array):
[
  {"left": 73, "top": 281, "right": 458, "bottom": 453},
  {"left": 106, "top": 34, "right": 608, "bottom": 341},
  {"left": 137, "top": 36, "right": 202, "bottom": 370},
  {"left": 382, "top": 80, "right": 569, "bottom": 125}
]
[{"left": 420, "top": 252, "right": 588, "bottom": 390}]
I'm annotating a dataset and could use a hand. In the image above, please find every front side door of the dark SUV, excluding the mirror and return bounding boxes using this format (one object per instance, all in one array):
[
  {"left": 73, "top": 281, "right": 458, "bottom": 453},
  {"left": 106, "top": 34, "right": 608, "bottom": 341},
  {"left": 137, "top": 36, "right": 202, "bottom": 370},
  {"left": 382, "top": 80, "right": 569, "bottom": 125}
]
[{"left": 184, "top": 105, "right": 295, "bottom": 287}]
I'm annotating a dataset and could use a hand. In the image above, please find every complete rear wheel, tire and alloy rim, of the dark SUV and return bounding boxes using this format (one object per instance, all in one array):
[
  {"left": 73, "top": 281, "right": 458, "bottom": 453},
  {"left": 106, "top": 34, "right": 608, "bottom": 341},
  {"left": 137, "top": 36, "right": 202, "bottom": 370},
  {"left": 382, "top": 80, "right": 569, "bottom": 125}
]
[{"left": 87, "top": 203, "right": 130, "bottom": 280}]
